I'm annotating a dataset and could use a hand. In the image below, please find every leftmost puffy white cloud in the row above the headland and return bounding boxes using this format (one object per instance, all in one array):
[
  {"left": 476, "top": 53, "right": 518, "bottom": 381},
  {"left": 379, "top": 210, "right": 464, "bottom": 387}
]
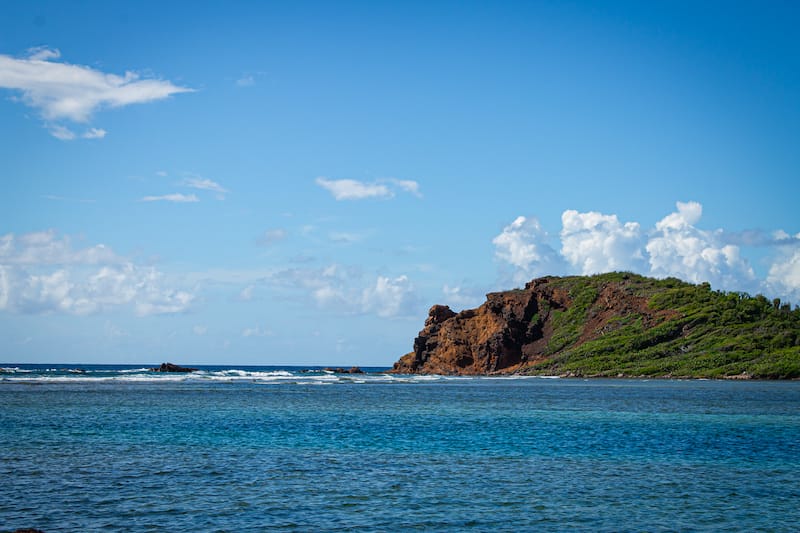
[{"left": 492, "top": 216, "right": 562, "bottom": 282}]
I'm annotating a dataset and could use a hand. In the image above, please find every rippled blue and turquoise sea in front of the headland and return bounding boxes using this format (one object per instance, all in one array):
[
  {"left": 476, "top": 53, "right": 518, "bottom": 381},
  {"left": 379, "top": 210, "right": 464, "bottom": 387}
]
[{"left": 0, "top": 365, "right": 800, "bottom": 531}]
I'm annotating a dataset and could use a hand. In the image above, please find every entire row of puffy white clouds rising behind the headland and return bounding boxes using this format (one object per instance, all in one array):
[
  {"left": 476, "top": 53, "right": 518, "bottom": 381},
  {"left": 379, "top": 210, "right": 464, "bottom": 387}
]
[{"left": 493, "top": 202, "right": 800, "bottom": 299}]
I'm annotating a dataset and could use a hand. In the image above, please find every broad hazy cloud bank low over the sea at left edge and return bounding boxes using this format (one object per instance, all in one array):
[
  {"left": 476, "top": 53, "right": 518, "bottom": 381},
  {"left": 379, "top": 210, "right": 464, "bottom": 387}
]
[{"left": 0, "top": 231, "right": 194, "bottom": 316}]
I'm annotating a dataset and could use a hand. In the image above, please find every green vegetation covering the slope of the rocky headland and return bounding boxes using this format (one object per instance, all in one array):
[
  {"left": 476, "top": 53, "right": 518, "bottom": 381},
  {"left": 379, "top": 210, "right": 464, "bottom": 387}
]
[{"left": 523, "top": 272, "right": 800, "bottom": 379}]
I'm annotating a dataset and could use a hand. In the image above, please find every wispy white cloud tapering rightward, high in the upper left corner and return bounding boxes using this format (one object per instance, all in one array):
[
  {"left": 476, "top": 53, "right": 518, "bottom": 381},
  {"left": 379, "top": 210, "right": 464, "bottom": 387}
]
[{"left": 0, "top": 47, "right": 192, "bottom": 140}]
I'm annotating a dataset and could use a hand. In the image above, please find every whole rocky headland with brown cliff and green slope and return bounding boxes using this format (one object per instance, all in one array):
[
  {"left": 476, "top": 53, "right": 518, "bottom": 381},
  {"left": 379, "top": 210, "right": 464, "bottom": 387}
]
[{"left": 392, "top": 273, "right": 800, "bottom": 379}]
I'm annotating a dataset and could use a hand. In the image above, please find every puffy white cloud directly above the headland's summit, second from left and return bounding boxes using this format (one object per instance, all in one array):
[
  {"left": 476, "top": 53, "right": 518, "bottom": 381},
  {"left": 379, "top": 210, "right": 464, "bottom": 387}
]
[{"left": 560, "top": 210, "right": 643, "bottom": 274}]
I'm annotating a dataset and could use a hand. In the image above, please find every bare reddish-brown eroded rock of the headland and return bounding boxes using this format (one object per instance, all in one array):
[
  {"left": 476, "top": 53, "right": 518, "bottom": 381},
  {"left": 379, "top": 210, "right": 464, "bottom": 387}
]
[{"left": 392, "top": 277, "right": 672, "bottom": 374}]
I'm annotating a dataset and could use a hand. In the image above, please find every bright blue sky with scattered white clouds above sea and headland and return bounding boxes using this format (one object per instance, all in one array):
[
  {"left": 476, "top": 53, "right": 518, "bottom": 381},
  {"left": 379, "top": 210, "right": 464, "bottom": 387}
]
[{"left": 0, "top": 1, "right": 800, "bottom": 366}]
